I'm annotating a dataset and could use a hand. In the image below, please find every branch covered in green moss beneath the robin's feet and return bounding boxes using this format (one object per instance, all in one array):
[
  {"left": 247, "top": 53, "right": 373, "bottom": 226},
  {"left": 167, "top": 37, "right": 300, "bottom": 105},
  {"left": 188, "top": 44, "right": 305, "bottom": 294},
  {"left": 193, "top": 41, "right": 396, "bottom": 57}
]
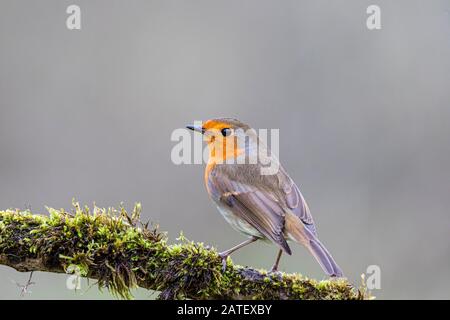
[{"left": 0, "top": 203, "right": 365, "bottom": 299}]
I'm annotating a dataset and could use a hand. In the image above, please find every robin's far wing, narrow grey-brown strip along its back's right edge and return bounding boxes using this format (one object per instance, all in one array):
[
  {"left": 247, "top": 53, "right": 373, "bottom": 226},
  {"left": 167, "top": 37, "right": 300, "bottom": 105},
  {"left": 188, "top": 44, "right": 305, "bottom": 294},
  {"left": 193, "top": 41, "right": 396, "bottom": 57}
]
[{"left": 278, "top": 168, "right": 317, "bottom": 235}]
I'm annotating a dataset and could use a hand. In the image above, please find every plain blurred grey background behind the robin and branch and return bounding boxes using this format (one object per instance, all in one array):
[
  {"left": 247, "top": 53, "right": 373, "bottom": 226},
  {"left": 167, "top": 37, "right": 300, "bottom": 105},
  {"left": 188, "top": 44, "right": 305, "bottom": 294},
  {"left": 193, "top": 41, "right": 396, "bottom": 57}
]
[{"left": 0, "top": 0, "right": 450, "bottom": 299}]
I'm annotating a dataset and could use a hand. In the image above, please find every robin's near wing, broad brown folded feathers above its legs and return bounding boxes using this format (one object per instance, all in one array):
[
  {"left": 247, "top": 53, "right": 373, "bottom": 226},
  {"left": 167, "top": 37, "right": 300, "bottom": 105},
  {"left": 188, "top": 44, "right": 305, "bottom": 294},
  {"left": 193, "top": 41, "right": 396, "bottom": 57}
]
[{"left": 211, "top": 174, "right": 291, "bottom": 254}]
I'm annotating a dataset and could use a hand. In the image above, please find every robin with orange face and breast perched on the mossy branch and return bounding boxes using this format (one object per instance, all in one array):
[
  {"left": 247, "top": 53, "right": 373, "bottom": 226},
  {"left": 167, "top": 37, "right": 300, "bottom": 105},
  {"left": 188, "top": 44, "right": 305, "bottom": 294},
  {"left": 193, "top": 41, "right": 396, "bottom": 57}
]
[{"left": 186, "top": 118, "right": 344, "bottom": 277}]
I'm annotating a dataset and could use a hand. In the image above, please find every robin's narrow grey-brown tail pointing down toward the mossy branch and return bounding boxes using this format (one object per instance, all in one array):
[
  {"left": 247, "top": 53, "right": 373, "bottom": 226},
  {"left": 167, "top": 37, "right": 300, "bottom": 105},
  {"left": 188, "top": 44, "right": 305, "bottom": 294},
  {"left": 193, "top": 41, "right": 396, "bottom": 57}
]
[{"left": 285, "top": 214, "right": 344, "bottom": 277}]
